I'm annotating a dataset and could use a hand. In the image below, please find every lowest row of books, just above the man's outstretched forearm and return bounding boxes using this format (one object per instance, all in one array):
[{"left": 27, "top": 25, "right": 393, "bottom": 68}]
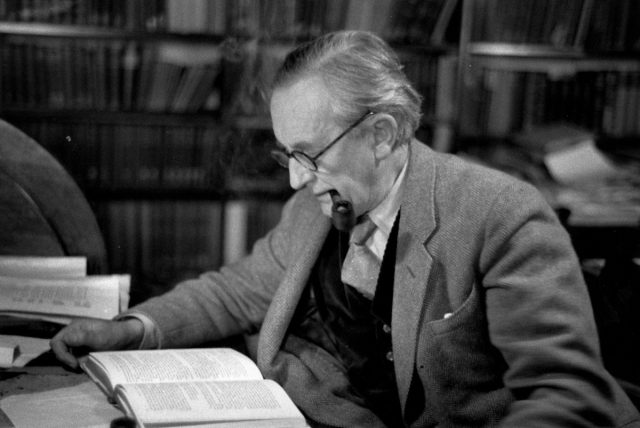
[{"left": 97, "top": 200, "right": 282, "bottom": 302}]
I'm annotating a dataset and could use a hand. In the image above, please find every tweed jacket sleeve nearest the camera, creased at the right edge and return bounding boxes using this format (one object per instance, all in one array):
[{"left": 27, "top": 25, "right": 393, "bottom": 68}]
[{"left": 480, "top": 184, "right": 632, "bottom": 427}]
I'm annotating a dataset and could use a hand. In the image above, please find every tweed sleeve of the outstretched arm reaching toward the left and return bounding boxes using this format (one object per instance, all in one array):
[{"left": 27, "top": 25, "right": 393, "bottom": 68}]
[{"left": 125, "top": 192, "right": 301, "bottom": 348}]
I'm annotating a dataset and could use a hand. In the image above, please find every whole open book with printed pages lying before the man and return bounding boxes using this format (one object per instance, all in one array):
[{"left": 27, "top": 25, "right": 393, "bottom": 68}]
[{"left": 80, "top": 348, "right": 308, "bottom": 427}]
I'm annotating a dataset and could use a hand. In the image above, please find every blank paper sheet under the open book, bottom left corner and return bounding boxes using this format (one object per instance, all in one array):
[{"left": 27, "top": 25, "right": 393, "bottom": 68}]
[{"left": 0, "top": 381, "right": 123, "bottom": 428}]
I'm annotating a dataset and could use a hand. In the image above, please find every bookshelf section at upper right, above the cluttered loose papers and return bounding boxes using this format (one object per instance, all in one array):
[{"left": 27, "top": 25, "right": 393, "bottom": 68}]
[{"left": 457, "top": 0, "right": 640, "bottom": 139}]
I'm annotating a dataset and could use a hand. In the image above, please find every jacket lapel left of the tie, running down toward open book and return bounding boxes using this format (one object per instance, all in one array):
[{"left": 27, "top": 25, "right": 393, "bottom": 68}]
[{"left": 258, "top": 209, "right": 331, "bottom": 370}]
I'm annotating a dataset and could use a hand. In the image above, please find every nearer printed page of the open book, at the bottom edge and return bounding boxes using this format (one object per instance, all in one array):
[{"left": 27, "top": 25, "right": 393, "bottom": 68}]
[{"left": 116, "top": 380, "right": 306, "bottom": 426}]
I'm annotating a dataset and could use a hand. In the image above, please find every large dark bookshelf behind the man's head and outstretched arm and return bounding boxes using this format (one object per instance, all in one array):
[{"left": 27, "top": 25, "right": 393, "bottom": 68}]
[{"left": 0, "top": 0, "right": 461, "bottom": 303}]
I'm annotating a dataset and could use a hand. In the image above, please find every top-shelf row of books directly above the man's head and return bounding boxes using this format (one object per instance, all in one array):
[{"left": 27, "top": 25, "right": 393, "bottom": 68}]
[{"left": 174, "top": 0, "right": 459, "bottom": 45}]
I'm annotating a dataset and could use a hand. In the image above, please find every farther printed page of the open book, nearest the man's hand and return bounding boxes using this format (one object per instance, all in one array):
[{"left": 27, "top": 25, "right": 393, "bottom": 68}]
[{"left": 81, "top": 348, "right": 262, "bottom": 395}]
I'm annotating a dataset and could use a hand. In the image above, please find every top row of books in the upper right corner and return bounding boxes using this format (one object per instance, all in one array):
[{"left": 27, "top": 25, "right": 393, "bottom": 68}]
[{"left": 471, "top": 0, "right": 640, "bottom": 51}]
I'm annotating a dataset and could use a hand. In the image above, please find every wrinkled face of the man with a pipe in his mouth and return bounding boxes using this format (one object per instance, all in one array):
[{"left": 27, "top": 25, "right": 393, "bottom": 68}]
[{"left": 271, "top": 77, "right": 380, "bottom": 216}]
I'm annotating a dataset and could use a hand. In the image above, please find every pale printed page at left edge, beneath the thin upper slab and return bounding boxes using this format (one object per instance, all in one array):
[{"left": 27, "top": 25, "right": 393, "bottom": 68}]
[{"left": 0, "top": 275, "right": 120, "bottom": 319}]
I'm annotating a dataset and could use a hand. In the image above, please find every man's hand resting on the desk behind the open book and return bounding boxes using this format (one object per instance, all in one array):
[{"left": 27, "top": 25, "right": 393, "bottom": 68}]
[{"left": 50, "top": 318, "right": 144, "bottom": 368}]
